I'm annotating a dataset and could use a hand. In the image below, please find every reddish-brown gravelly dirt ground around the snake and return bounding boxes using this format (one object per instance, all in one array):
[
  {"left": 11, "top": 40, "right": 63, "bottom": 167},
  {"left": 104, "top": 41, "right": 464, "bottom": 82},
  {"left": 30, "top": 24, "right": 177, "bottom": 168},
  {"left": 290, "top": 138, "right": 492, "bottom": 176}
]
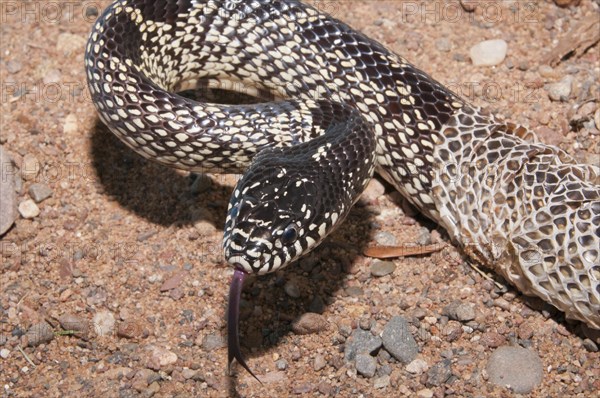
[{"left": 0, "top": 0, "right": 600, "bottom": 397}]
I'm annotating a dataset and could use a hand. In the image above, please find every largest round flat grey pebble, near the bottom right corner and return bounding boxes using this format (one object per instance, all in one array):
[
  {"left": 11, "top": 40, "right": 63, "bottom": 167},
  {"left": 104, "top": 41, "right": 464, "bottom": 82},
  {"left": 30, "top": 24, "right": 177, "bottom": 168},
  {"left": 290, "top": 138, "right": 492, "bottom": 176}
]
[{"left": 486, "top": 346, "right": 543, "bottom": 394}]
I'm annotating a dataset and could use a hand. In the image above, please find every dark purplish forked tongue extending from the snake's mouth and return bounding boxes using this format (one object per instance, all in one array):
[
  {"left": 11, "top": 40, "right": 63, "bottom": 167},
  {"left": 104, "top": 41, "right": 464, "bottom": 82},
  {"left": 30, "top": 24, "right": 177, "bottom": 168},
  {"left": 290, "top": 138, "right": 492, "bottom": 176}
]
[{"left": 227, "top": 268, "right": 262, "bottom": 384}]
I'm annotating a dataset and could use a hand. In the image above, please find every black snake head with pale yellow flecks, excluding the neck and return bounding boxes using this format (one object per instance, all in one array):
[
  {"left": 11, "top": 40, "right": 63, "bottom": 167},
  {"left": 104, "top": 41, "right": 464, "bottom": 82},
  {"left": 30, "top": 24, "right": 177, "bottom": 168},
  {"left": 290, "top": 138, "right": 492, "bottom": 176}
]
[{"left": 223, "top": 157, "right": 324, "bottom": 275}]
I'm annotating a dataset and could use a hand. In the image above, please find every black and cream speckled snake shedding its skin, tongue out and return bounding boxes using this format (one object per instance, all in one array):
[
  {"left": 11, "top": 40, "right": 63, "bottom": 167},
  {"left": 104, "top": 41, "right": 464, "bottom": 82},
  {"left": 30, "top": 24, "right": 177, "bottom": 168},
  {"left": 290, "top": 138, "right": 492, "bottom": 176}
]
[{"left": 85, "top": 0, "right": 600, "bottom": 380}]
